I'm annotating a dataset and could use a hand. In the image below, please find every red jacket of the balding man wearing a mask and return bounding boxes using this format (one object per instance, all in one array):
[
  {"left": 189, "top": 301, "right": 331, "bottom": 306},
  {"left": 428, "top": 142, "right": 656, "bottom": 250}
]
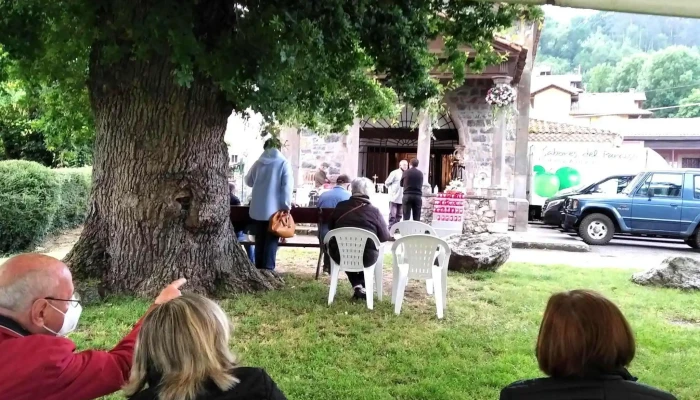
[{"left": 0, "top": 316, "right": 141, "bottom": 400}]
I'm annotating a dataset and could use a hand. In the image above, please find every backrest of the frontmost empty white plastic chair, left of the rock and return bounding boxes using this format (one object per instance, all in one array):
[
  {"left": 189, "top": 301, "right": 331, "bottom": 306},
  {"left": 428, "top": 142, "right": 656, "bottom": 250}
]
[{"left": 391, "top": 234, "right": 451, "bottom": 279}]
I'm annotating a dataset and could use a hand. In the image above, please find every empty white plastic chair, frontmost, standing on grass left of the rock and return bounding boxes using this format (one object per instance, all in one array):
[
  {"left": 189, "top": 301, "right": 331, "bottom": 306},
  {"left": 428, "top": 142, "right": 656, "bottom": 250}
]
[{"left": 391, "top": 235, "right": 451, "bottom": 319}]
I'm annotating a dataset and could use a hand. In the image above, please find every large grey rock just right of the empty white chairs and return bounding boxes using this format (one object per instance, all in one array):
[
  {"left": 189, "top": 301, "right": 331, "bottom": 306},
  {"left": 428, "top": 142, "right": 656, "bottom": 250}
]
[{"left": 445, "top": 233, "right": 511, "bottom": 273}]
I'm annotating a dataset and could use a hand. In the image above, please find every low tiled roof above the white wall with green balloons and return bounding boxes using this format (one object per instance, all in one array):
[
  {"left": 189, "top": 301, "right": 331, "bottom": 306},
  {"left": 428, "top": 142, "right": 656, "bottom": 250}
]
[{"left": 529, "top": 119, "right": 620, "bottom": 143}]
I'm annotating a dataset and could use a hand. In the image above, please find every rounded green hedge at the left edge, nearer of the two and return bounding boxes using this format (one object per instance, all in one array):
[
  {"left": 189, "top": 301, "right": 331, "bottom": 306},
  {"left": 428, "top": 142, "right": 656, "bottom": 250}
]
[{"left": 0, "top": 160, "right": 59, "bottom": 253}]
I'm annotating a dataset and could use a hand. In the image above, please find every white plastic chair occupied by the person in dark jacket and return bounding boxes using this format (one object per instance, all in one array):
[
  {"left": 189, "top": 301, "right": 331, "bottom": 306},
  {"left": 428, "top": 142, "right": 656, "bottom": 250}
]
[{"left": 323, "top": 228, "right": 383, "bottom": 310}]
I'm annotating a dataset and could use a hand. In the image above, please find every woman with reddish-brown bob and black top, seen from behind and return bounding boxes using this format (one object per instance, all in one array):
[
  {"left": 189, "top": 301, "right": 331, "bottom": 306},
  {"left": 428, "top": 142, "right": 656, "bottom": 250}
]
[{"left": 501, "top": 290, "right": 675, "bottom": 400}]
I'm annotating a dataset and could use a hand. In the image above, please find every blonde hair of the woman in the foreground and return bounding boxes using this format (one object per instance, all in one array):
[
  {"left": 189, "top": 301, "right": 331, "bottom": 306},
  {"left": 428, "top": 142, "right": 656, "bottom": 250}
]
[{"left": 124, "top": 294, "right": 238, "bottom": 400}]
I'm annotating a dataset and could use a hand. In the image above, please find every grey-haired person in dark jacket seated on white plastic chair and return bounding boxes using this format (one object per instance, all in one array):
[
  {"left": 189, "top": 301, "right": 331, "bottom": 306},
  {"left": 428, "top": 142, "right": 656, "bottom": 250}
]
[{"left": 328, "top": 178, "right": 390, "bottom": 299}]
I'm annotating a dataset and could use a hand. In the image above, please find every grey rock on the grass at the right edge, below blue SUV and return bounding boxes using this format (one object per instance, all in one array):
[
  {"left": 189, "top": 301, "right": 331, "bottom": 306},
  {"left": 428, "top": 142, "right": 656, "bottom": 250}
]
[{"left": 632, "top": 257, "right": 700, "bottom": 290}]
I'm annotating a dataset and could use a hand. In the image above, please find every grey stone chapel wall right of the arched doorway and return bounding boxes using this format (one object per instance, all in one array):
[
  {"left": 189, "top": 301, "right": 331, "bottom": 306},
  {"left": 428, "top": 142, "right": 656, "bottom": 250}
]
[{"left": 446, "top": 79, "right": 516, "bottom": 195}]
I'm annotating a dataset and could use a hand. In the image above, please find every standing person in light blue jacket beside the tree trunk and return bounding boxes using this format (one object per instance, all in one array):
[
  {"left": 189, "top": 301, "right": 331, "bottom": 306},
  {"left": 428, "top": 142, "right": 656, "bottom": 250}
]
[{"left": 245, "top": 138, "right": 294, "bottom": 271}]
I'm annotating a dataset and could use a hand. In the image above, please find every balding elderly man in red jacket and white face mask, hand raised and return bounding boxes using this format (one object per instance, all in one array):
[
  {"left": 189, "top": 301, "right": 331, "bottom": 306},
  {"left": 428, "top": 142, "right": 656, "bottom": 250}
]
[{"left": 0, "top": 254, "right": 185, "bottom": 400}]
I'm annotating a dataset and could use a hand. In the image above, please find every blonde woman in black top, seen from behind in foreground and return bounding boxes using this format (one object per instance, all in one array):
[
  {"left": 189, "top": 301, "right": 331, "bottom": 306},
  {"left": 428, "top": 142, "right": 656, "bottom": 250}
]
[{"left": 124, "top": 294, "right": 286, "bottom": 400}]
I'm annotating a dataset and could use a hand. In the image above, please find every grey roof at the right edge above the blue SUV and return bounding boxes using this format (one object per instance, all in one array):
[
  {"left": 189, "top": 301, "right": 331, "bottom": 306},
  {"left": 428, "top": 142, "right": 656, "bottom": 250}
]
[{"left": 606, "top": 118, "right": 700, "bottom": 140}]
